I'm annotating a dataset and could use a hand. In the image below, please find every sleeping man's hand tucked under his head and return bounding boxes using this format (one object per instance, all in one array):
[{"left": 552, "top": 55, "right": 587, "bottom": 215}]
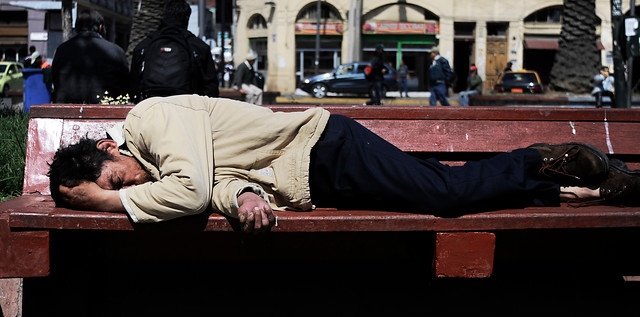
[{"left": 60, "top": 182, "right": 125, "bottom": 212}]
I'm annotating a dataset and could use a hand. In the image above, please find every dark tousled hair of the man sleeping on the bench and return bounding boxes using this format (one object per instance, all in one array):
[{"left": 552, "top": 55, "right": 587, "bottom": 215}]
[{"left": 47, "top": 138, "right": 113, "bottom": 207}]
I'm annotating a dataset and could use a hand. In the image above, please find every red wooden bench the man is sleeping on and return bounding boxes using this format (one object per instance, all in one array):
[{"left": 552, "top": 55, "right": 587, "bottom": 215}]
[{"left": 0, "top": 105, "right": 640, "bottom": 316}]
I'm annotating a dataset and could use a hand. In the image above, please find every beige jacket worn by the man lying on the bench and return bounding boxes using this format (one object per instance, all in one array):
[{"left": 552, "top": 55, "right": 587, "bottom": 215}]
[{"left": 110, "top": 95, "right": 329, "bottom": 222}]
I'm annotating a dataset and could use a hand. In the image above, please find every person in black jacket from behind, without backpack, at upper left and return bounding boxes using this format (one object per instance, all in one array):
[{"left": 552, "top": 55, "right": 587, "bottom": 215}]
[{"left": 51, "top": 10, "right": 129, "bottom": 103}]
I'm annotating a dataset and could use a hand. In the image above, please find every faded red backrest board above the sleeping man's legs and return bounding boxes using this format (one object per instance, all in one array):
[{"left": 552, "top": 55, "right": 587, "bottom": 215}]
[{"left": 358, "top": 119, "right": 640, "bottom": 155}]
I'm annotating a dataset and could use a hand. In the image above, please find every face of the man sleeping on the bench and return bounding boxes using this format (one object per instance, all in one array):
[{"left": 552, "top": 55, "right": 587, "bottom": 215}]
[{"left": 96, "top": 154, "right": 152, "bottom": 190}]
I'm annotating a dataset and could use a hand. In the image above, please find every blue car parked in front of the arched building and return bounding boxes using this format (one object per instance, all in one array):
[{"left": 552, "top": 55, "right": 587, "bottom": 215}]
[{"left": 300, "top": 62, "right": 398, "bottom": 98}]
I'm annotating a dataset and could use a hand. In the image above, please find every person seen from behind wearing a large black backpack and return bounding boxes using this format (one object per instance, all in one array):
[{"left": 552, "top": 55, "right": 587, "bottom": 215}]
[{"left": 131, "top": 0, "right": 219, "bottom": 101}]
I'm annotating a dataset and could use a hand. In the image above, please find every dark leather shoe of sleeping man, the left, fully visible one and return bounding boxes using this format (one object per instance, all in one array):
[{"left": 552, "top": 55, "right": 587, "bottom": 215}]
[{"left": 529, "top": 143, "right": 609, "bottom": 187}]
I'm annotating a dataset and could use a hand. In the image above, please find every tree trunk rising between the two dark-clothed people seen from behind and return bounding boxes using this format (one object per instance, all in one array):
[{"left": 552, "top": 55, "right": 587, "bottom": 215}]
[{"left": 127, "top": 0, "right": 164, "bottom": 64}]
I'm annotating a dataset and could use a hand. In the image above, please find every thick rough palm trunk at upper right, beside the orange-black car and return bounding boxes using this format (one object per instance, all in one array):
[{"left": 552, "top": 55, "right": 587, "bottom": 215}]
[{"left": 551, "top": 0, "right": 600, "bottom": 93}]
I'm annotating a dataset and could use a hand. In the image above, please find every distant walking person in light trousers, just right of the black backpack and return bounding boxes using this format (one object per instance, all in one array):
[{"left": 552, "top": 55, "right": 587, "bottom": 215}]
[{"left": 233, "top": 51, "right": 264, "bottom": 105}]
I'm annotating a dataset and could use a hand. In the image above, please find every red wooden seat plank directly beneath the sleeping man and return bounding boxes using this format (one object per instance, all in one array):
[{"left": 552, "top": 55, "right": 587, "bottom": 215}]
[{"left": 5, "top": 194, "right": 640, "bottom": 232}]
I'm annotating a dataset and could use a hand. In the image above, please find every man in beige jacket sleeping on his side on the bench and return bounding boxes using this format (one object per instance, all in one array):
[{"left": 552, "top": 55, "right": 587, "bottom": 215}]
[{"left": 49, "top": 95, "right": 640, "bottom": 232}]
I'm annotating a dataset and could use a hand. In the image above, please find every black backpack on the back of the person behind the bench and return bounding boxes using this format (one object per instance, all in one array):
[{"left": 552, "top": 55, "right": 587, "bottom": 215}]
[{"left": 139, "top": 26, "right": 202, "bottom": 98}]
